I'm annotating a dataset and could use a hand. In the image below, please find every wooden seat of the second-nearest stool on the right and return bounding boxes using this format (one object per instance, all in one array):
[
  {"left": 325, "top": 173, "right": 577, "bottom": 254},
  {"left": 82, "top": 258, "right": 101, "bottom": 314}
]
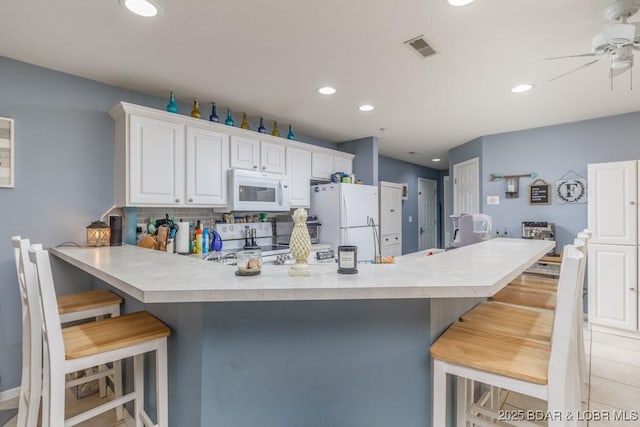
[{"left": 462, "top": 302, "right": 553, "bottom": 344}]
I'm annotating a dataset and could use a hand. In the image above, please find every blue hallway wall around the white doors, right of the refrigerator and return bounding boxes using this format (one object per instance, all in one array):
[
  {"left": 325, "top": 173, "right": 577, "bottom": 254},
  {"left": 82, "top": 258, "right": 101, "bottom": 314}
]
[{"left": 378, "top": 156, "right": 443, "bottom": 254}]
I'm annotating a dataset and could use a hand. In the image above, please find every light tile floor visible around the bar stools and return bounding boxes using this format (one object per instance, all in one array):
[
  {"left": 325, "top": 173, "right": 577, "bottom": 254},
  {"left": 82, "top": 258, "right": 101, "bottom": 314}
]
[{"left": 4, "top": 322, "right": 640, "bottom": 427}]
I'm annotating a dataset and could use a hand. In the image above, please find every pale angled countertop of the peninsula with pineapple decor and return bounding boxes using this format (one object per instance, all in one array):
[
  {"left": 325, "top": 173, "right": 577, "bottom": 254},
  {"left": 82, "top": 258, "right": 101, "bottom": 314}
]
[{"left": 49, "top": 238, "right": 554, "bottom": 303}]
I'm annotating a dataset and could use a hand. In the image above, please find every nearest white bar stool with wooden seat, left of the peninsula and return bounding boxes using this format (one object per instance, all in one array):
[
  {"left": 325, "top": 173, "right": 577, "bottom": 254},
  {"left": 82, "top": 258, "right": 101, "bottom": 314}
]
[{"left": 25, "top": 247, "right": 171, "bottom": 427}]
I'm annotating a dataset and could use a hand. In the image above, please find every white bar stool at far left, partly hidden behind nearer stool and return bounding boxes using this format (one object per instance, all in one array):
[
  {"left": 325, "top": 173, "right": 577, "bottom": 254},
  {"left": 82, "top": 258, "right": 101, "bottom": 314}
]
[{"left": 11, "top": 236, "right": 123, "bottom": 427}]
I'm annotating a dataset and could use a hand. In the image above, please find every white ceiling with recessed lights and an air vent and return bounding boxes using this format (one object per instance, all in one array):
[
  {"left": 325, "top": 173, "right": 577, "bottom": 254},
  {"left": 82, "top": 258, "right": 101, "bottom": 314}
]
[{"left": 0, "top": 0, "right": 640, "bottom": 169}]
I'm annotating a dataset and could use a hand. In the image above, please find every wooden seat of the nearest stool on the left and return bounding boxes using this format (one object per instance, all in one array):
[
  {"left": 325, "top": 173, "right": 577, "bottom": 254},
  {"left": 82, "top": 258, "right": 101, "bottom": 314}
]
[{"left": 62, "top": 311, "right": 171, "bottom": 360}]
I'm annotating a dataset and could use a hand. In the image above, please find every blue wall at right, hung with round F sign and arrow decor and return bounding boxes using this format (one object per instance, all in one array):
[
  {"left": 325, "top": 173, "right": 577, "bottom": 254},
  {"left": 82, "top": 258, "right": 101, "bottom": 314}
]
[{"left": 450, "top": 112, "right": 640, "bottom": 251}]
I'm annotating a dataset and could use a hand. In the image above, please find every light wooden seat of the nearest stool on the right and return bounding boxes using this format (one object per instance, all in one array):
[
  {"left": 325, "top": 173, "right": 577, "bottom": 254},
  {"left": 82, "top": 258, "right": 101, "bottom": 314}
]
[{"left": 430, "top": 322, "right": 550, "bottom": 384}]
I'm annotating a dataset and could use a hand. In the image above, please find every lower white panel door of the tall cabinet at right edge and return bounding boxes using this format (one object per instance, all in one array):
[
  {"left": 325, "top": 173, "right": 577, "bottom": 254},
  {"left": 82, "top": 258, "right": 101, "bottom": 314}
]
[{"left": 588, "top": 243, "right": 638, "bottom": 330}]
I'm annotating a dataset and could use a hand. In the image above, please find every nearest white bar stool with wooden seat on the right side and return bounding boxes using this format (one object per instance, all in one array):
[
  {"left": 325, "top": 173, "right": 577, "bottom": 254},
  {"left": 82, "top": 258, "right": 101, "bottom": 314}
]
[{"left": 430, "top": 246, "right": 585, "bottom": 427}]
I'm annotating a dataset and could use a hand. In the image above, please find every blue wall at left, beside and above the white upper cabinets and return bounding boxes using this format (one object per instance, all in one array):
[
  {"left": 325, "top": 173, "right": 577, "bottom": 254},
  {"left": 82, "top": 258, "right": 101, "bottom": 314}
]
[{"left": 0, "top": 57, "right": 335, "bottom": 402}]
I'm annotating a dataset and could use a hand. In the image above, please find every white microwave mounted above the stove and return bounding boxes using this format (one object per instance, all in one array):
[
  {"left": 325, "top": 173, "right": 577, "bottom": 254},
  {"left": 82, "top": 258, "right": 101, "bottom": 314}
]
[{"left": 229, "top": 169, "right": 291, "bottom": 212}]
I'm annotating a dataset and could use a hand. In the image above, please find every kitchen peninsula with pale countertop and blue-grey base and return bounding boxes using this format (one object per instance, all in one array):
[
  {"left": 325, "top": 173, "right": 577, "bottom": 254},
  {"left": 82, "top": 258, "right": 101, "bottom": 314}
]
[{"left": 50, "top": 239, "right": 553, "bottom": 427}]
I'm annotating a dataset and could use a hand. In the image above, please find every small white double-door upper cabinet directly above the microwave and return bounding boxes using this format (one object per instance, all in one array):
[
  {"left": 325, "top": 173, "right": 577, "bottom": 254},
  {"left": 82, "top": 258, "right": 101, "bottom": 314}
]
[{"left": 231, "top": 135, "right": 285, "bottom": 174}]
